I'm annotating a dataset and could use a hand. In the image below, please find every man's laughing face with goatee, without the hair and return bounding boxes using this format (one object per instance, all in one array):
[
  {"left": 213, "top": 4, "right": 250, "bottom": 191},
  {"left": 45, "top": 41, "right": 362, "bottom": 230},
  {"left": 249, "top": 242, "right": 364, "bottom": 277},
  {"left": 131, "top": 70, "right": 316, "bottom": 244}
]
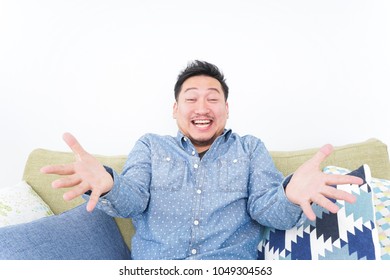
[{"left": 173, "top": 76, "right": 229, "bottom": 152}]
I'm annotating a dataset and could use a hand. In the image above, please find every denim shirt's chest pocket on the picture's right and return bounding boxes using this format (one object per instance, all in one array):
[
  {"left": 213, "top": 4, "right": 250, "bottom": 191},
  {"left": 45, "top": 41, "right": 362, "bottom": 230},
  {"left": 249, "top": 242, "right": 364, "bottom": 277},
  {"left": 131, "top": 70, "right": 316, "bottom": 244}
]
[{"left": 218, "top": 157, "right": 249, "bottom": 192}]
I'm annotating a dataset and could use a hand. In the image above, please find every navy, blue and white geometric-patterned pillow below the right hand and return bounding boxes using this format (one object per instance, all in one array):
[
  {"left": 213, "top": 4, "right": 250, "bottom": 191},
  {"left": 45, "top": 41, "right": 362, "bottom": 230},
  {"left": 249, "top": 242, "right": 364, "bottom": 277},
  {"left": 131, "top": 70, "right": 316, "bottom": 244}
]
[{"left": 259, "top": 165, "right": 380, "bottom": 260}]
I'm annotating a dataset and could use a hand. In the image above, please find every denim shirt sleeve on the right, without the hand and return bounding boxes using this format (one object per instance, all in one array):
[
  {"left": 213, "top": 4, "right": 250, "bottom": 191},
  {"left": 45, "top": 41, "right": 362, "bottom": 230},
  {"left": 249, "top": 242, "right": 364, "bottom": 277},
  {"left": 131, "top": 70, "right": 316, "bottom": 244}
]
[{"left": 248, "top": 140, "right": 302, "bottom": 230}]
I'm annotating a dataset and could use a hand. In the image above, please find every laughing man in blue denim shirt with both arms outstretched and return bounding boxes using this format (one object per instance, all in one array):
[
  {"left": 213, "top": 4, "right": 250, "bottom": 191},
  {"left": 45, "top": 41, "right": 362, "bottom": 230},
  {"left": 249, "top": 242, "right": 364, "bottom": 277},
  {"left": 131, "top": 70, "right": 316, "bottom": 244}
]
[{"left": 42, "top": 61, "right": 362, "bottom": 259}]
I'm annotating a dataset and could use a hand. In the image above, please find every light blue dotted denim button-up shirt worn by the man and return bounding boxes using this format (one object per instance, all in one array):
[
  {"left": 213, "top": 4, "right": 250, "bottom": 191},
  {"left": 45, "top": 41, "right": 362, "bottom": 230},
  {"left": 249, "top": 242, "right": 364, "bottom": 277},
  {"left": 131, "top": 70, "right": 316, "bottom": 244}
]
[{"left": 97, "top": 130, "right": 302, "bottom": 259}]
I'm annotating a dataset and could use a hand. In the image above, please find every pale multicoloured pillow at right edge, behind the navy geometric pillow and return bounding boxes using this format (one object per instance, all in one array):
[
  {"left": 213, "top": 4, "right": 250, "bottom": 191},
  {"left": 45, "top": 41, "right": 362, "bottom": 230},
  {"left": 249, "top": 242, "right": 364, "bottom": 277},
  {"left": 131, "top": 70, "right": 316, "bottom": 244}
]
[{"left": 324, "top": 166, "right": 390, "bottom": 260}]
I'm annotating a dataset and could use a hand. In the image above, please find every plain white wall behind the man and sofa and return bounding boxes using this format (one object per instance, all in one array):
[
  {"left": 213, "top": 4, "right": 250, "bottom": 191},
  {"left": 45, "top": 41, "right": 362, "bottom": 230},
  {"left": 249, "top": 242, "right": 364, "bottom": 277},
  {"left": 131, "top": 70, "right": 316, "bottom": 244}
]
[{"left": 0, "top": 0, "right": 390, "bottom": 188}]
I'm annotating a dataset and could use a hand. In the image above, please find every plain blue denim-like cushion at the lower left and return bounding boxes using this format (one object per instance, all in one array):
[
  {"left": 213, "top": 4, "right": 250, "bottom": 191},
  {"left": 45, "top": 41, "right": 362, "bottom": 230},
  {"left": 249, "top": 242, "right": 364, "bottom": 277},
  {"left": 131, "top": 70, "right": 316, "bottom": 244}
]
[{"left": 0, "top": 204, "right": 130, "bottom": 260}]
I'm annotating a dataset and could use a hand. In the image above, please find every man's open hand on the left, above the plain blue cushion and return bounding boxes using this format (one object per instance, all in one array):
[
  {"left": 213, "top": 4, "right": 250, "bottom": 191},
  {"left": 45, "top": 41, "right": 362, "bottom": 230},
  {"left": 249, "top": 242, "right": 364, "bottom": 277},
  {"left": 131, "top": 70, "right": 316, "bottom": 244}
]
[{"left": 41, "top": 133, "right": 114, "bottom": 211}]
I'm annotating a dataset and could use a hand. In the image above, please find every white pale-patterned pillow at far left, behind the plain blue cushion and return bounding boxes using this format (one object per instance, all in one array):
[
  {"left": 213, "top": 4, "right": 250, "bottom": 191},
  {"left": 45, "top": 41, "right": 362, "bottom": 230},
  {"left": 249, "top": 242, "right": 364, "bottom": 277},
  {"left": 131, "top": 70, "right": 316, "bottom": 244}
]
[{"left": 0, "top": 181, "right": 54, "bottom": 227}]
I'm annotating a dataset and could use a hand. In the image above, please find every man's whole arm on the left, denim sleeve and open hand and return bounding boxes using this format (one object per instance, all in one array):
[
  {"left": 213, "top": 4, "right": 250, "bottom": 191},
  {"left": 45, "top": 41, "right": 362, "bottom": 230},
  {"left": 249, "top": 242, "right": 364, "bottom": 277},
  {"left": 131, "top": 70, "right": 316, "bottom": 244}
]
[{"left": 41, "top": 133, "right": 151, "bottom": 217}]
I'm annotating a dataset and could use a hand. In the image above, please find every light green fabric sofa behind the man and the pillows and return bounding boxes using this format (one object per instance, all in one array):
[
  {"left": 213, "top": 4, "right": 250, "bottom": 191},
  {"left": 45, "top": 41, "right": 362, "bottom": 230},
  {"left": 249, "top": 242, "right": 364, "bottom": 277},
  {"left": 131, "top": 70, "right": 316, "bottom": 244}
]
[{"left": 23, "top": 139, "right": 390, "bottom": 247}]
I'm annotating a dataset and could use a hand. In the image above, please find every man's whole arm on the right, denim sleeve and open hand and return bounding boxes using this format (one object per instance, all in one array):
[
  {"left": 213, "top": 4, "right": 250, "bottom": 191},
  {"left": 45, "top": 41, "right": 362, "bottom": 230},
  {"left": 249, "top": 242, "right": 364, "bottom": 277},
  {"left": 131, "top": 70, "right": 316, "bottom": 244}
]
[{"left": 248, "top": 139, "right": 362, "bottom": 229}]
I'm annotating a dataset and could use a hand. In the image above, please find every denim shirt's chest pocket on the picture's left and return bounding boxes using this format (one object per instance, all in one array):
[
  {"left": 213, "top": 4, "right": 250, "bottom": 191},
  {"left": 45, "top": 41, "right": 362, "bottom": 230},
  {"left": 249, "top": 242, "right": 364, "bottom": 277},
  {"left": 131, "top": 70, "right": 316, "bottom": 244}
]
[{"left": 150, "top": 156, "right": 185, "bottom": 191}]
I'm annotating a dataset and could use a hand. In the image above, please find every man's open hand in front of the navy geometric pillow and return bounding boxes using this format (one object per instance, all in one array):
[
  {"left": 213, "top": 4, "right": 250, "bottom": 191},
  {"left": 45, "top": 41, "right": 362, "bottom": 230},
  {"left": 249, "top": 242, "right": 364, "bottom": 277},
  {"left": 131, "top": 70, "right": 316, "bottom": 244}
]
[{"left": 286, "top": 145, "right": 363, "bottom": 221}]
